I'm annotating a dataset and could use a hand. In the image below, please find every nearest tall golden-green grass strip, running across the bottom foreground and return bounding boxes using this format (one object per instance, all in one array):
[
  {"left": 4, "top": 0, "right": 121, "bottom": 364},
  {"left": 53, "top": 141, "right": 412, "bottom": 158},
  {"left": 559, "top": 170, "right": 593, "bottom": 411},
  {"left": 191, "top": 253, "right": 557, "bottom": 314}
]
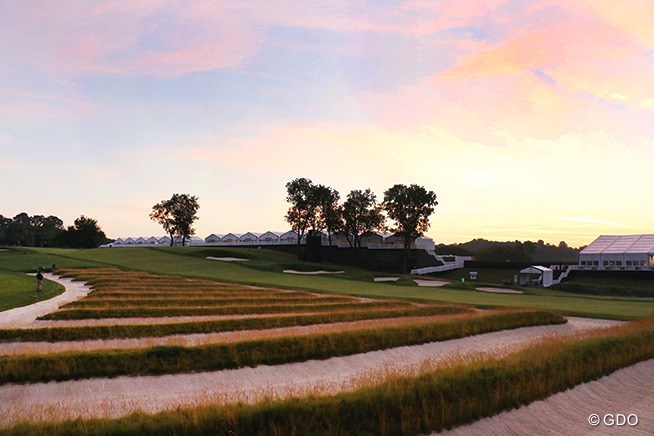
[{"left": 0, "top": 320, "right": 654, "bottom": 436}]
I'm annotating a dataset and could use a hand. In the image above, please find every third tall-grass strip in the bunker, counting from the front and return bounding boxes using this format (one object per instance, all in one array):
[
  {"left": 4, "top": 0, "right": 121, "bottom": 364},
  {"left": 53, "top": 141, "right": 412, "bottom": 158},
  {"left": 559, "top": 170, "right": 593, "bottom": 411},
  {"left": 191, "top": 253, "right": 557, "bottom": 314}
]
[{"left": 0, "top": 305, "right": 470, "bottom": 342}]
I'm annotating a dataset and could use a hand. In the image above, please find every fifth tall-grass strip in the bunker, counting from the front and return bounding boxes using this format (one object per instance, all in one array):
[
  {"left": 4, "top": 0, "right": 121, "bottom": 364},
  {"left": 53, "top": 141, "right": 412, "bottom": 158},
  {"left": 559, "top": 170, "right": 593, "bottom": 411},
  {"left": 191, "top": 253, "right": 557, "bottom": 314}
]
[{"left": 62, "top": 296, "right": 355, "bottom": 309}]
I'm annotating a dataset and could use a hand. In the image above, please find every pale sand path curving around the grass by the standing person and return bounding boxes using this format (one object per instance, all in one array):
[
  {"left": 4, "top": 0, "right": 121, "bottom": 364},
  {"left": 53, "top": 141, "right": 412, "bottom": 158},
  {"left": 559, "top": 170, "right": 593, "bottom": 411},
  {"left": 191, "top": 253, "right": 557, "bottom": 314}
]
[{"left": 0, "top": 273, "right": 91, "bottom": 328}]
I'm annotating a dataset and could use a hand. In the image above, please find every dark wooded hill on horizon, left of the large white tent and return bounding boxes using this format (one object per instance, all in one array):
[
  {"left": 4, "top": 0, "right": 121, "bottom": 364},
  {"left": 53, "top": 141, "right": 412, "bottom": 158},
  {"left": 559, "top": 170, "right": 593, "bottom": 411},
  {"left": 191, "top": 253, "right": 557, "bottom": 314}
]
[{"left": 435, "top": 239, "right": 580, "bottom": 264}]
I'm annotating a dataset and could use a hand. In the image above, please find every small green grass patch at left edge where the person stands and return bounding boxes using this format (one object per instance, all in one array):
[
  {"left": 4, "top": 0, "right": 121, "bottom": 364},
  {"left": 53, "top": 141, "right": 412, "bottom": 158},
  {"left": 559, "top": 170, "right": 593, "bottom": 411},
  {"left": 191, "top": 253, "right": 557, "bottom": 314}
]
[{"left": 0, "top": 270, "right": 64, "bottom": 316}]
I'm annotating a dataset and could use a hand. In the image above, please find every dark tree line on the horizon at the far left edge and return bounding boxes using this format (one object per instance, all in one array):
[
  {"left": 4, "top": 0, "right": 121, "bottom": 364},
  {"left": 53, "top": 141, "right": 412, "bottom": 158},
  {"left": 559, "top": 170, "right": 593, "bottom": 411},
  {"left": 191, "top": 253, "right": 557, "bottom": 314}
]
[{"left": 0, "top": 212, "right": 111, "bottom": 248}]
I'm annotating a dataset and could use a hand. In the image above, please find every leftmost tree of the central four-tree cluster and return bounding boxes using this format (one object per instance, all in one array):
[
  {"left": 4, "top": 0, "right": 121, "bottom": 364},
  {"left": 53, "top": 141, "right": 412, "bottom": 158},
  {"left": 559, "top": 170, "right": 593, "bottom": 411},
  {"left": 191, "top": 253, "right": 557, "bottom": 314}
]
[{"left": 284, "top": 178, "right": 316, "bottom": 255}]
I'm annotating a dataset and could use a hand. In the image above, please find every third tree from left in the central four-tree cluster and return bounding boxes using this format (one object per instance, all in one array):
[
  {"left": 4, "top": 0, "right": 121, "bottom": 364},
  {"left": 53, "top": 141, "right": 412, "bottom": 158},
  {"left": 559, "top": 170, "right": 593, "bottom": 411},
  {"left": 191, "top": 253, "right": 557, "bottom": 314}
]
[{"left": 343, "top": 189, "right": 384, "bottom": 253}]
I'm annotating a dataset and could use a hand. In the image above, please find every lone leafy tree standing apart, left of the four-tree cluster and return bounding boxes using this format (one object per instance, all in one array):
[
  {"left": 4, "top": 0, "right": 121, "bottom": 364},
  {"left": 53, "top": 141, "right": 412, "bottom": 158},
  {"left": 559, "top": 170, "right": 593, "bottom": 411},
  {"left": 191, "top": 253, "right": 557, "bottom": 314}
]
[{"left": 150, "top": 194, "right": 200, "bottom": 246}]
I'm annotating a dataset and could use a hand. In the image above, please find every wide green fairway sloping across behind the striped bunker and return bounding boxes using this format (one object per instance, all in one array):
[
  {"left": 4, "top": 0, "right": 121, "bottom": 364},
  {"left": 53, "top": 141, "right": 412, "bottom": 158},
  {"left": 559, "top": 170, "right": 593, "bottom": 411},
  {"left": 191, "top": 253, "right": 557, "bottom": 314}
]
[{"left": 5, "top": 247, "right": 654, "bottom": 319}]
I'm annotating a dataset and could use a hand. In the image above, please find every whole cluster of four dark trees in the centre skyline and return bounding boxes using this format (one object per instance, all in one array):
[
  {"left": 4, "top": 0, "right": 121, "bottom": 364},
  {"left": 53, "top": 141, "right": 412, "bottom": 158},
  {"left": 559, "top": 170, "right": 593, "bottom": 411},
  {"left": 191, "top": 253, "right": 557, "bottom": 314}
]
[{"left": 284, "top": 178, "right": 438, "bottom": 272}]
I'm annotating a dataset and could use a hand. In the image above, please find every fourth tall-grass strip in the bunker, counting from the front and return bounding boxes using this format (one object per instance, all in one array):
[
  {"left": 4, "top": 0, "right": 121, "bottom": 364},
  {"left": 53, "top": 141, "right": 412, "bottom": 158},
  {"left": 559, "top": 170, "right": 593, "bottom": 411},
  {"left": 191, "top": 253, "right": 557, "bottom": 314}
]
[{"left": 38, "top": 301, "right": 410, "bottom": 319}]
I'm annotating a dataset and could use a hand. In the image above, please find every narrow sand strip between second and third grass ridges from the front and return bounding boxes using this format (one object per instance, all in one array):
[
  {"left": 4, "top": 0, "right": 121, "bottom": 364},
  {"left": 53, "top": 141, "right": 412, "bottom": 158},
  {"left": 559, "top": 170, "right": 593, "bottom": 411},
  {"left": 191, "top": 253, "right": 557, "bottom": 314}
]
[{"left": 0, "top": 313, "right": 498, "bottom": 356}]
